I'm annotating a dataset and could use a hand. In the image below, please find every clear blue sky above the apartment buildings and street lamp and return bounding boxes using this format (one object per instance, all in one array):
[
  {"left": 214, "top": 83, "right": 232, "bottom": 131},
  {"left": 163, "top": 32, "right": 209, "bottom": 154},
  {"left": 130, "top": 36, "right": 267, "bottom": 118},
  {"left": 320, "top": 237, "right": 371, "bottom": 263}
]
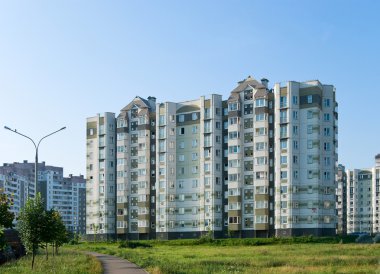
[{"left": 0, "top": 0, "right": 380, "bottom": 174}]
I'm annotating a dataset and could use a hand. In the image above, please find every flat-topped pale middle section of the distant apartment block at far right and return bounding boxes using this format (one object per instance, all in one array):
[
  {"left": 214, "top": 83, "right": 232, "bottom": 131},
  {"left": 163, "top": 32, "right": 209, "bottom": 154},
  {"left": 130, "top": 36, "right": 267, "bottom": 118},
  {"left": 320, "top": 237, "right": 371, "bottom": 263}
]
[{"left": 347, "top": 168, "right": 373, "bottom": 233}]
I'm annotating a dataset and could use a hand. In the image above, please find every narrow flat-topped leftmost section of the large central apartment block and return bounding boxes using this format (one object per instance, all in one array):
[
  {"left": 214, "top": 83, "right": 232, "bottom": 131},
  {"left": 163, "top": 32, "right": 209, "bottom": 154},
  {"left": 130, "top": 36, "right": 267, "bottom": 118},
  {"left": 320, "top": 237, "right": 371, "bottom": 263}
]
[{"left": 86, "top": 112, "right": 116, "bottom": 239}]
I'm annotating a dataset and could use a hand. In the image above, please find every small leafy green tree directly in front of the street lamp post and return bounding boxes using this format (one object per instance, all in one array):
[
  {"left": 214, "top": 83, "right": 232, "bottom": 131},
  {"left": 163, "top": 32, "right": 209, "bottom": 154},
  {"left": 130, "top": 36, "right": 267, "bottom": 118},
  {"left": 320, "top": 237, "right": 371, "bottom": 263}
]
[{"left": 17, "top": 193, "right": 46, "bottom": 269}]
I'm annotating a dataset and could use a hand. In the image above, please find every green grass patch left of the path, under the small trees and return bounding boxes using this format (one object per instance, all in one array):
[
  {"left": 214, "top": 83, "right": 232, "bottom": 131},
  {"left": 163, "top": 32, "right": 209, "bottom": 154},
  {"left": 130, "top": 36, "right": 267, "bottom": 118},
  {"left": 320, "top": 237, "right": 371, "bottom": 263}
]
[{"left": 0, "top": 248, "right": 103, "bottom": 274}]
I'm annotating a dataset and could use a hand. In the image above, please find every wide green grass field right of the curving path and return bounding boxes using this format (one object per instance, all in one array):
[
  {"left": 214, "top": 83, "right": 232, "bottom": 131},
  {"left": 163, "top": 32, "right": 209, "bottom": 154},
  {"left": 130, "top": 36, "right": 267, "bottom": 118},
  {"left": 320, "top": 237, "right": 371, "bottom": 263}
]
[{"left": 71, "top": 239, "right": 380, "bottom": 274}]
